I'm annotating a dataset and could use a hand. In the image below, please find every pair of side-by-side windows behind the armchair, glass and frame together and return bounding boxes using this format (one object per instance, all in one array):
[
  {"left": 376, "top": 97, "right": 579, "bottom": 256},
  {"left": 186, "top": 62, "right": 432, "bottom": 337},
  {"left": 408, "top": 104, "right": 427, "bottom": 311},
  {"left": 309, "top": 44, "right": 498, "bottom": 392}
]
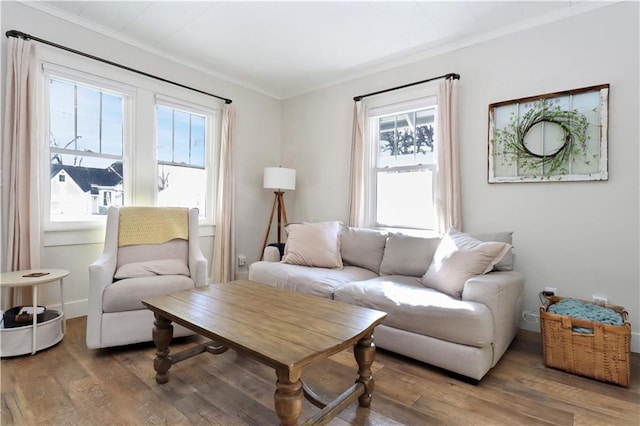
[{"left": 39, "top": 55, "right": 222, "bottom": 236}]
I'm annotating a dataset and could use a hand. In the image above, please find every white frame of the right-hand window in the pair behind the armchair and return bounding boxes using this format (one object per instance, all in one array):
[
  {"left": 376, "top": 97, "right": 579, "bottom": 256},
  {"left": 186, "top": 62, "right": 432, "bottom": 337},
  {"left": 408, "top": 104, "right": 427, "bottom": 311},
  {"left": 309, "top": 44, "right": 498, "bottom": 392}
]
[{"left": 153, "top": 94, "right": 221, "bottom": 226}]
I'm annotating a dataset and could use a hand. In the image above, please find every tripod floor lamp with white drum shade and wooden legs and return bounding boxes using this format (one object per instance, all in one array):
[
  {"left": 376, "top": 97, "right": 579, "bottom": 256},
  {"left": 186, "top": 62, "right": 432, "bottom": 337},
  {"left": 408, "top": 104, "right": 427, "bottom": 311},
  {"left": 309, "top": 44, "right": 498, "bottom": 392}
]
[{"left": 260, "top": 167, "right": 296, "bottom": 260}]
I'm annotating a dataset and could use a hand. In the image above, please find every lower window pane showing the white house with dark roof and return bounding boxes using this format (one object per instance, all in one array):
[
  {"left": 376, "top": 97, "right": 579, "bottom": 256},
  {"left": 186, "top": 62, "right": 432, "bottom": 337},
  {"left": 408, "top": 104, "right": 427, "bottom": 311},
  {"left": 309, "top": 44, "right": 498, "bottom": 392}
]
[{"left": 50, "top": 157, "right": 124, "bottom": 221}]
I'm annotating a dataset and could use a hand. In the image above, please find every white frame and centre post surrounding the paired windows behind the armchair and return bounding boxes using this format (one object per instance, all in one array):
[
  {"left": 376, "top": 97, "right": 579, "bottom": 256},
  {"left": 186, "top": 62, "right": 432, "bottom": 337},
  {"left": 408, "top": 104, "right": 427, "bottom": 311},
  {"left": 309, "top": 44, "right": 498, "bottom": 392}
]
[{"left": 37, "top": 46, "right": 223, "bottom": 247}]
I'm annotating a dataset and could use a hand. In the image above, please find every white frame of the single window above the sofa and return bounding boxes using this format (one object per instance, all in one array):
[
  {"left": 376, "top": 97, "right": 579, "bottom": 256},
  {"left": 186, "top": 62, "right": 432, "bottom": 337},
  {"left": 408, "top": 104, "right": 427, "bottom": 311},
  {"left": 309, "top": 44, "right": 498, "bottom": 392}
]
[{"left": 364, "top": 90, "right": 438, "bottom": 234}]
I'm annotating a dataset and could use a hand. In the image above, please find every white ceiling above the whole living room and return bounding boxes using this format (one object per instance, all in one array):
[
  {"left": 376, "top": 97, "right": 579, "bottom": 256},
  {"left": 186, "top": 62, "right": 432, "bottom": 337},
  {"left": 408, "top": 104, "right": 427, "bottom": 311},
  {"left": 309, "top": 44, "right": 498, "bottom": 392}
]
[{"left": 30, "top": 1, "right": 608, "bottom": 99}]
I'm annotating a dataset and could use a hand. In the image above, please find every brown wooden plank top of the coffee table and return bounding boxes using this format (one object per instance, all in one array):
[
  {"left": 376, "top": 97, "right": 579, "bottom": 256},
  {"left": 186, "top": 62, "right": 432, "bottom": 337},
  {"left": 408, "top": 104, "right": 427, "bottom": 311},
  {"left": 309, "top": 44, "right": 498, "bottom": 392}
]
[{"left": 142, "top": 280, "right": 387, "bottom": 369}]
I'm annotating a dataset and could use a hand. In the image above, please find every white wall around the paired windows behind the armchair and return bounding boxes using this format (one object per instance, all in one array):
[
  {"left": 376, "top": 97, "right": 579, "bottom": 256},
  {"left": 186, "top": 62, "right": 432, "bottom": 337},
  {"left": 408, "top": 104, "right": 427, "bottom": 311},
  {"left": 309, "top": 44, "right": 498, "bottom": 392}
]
[{"left": 0, "top": 1, "right": 281, "bottom": 317}]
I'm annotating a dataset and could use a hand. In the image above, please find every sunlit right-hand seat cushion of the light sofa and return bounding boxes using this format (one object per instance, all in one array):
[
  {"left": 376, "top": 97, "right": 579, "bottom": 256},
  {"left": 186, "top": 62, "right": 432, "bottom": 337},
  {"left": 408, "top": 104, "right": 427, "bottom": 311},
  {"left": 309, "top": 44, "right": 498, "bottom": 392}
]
[{"left": 334, "top": 275, "right": 494, "bottom": 348}]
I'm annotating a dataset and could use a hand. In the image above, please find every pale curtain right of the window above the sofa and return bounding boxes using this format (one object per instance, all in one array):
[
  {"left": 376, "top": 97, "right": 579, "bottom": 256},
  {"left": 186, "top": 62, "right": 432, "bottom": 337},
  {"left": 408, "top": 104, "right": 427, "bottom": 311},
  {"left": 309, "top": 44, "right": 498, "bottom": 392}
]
[{"left": 436, "top": 79, "right": 462, "bottom": 234}]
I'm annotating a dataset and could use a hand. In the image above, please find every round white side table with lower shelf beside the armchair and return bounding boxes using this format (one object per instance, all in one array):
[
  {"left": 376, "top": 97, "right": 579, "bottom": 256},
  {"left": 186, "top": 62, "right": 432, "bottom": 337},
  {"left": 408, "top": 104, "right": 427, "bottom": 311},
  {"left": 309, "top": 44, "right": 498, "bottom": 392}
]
[{"left": 0, "top": 269, "right": 69, "bottom": 356}]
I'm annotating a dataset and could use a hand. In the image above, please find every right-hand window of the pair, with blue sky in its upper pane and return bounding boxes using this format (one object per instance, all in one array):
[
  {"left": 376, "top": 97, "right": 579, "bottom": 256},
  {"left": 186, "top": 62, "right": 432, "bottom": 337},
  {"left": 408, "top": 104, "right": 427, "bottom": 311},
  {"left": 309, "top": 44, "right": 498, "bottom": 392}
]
[{"left": 156, "top": 100, "right": 213, "bottom": 218}]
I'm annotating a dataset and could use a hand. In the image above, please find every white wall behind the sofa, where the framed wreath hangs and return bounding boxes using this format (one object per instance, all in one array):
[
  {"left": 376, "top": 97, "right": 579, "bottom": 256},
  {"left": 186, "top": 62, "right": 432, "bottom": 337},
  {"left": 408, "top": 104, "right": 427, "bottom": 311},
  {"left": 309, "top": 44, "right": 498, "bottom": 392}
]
[{"left": 282, "top": 2, "right": 640, "bottom": 352}]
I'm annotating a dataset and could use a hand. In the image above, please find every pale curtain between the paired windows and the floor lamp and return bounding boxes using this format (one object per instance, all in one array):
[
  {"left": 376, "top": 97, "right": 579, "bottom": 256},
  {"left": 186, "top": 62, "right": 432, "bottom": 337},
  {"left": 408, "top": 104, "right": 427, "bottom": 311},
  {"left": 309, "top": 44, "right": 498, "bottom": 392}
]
[{"left": 211, "top": 104, "right": 236, "bottom": 283}]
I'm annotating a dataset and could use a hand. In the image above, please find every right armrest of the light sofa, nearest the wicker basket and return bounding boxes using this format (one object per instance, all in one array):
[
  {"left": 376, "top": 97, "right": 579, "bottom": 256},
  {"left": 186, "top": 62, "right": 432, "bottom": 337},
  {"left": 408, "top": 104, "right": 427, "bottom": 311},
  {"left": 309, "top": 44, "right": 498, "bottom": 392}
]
[{"left": 462, "top": 271, "right": 524, "bottom": 365}]
